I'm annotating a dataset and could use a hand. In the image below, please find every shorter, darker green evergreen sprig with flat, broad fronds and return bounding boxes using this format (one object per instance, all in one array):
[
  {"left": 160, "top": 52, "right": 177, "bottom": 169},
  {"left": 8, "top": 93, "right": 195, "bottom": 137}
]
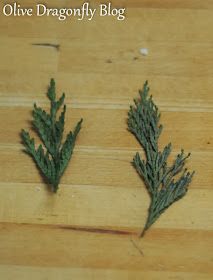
[{"left": 21, "top": 79, "right": 83, "bottom": 192}]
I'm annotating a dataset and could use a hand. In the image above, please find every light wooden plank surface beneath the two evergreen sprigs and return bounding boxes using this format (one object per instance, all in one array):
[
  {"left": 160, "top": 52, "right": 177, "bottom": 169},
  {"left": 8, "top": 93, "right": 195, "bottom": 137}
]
[{"left": 0, "top": 0, "right": 213, "bottom": 280}]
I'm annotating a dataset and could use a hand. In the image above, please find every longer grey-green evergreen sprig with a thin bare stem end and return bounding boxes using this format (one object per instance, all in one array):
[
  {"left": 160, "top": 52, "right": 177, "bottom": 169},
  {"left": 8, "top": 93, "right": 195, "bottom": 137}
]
[{"left": 128, "top": 81, "right": 194, "bottom": 236}]
